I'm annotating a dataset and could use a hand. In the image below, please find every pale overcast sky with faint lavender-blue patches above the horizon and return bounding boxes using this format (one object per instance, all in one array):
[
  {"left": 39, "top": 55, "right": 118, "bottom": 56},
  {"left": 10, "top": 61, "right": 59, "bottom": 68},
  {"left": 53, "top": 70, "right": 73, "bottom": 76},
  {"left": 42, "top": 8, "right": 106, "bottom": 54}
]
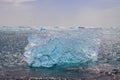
[{"left": 0, "top": 0, "right": 120, "bottom": 27}]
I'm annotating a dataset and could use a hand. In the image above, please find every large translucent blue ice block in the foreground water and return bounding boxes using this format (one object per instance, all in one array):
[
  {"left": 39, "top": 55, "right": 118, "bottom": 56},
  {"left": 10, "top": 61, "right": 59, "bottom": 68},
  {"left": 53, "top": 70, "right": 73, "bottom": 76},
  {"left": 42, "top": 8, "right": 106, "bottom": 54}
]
[{"left": 24, "top": 28, "right": 102, "bottom": 68}]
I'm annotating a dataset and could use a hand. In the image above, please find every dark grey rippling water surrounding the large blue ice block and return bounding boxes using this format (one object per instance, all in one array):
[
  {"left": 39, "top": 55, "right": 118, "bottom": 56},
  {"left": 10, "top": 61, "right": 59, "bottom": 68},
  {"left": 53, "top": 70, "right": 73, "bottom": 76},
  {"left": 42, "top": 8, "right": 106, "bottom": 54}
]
[{"left": 0, "top": 29, "right": 120, "bottom": 77}]
